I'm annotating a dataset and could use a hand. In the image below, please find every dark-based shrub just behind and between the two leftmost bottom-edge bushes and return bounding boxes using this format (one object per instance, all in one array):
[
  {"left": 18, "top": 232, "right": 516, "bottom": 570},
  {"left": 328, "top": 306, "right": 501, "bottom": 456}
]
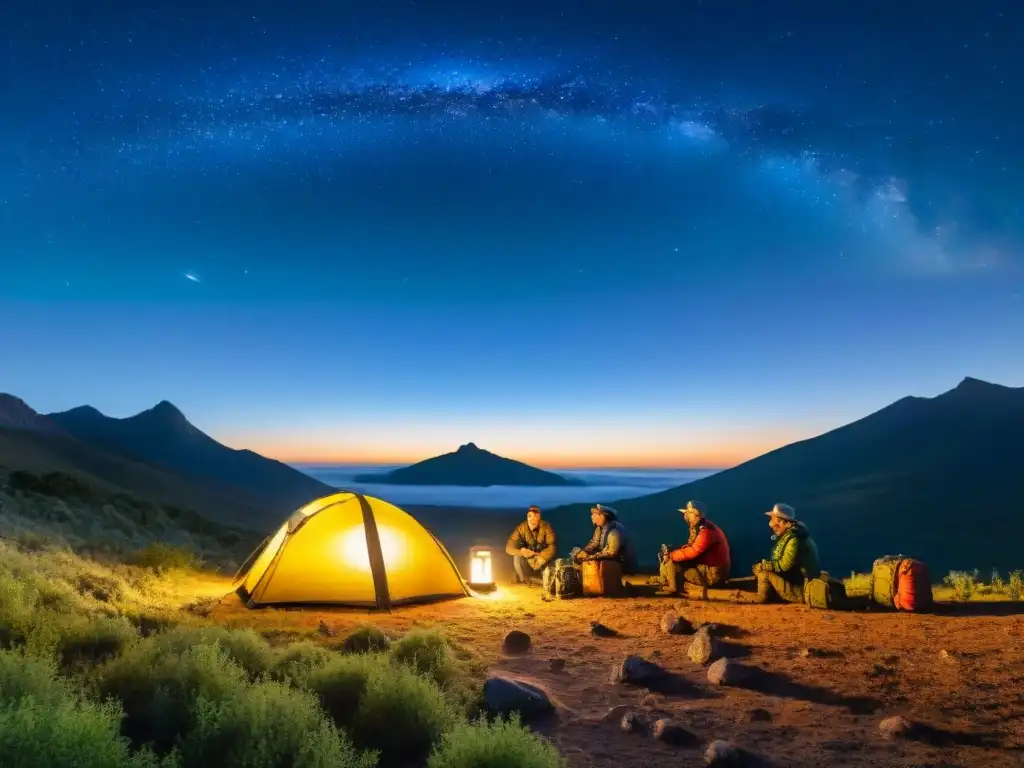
[{"left": 98, "top": 638, "right": 252, "bottom": 753}]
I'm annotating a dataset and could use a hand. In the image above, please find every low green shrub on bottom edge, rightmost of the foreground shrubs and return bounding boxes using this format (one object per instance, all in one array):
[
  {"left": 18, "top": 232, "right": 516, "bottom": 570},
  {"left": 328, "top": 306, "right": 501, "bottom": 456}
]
[{"left": 426, "top": 716, "right": 567, "bottom": 768}]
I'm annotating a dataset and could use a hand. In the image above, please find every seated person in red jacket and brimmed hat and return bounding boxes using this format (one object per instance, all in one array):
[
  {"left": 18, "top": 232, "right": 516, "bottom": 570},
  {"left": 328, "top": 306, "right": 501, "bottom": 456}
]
[{"left": 657, "top": 502, "right": 732, "bottom": 600}]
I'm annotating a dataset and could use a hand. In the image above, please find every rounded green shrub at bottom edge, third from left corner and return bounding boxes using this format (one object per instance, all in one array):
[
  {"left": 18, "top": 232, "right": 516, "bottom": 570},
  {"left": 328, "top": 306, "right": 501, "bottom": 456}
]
[{"left": 351, "top": 665, "right": 459, "bottom": 766}]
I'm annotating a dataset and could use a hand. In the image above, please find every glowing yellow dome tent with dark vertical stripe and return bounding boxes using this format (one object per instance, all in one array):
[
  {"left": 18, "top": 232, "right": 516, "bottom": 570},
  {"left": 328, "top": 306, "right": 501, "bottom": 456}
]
[{"left": 234, "top": 490, "right": 471, "bottom": 610}]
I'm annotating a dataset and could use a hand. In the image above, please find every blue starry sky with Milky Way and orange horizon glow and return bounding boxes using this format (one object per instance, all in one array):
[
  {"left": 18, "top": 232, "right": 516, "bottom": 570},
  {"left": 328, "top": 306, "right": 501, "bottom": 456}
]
[{"left": 0, "top": 0, "right": 1024, "bottom": 467}]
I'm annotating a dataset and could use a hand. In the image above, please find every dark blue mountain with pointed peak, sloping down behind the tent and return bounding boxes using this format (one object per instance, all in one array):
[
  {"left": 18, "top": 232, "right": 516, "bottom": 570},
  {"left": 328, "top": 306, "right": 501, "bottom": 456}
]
[{"left": 47, "top": 400, "right": 334, "bottom": 514}]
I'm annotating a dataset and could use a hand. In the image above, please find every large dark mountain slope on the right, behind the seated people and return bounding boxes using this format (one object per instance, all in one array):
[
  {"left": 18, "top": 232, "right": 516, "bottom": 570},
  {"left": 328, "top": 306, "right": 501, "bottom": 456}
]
[{"left": 548, "top": 378, "right": 1024, "bottom": 577}]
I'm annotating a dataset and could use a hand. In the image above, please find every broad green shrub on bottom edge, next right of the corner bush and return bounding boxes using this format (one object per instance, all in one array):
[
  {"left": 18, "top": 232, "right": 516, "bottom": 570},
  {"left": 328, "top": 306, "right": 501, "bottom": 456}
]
[{"left": 180, "top": 681, "right": 377, "bottom": 768}]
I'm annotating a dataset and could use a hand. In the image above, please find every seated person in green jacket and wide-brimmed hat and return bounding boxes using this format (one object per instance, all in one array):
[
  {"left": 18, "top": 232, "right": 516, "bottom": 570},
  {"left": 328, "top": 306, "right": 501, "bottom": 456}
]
[{"left": 754, "top": 504, "right": 821, "bottom": 603}]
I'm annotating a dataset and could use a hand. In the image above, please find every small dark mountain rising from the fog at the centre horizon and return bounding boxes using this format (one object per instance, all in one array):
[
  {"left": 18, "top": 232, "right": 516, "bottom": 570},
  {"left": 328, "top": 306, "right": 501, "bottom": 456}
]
[{"left": 355, "top": 442, "right": 586, "bottom": 486}]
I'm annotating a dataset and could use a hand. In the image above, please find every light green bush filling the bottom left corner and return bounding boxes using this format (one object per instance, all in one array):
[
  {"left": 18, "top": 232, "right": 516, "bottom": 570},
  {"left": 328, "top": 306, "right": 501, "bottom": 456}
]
[{"left": 0, "top": 651, "right": 157, "bottom": 768}]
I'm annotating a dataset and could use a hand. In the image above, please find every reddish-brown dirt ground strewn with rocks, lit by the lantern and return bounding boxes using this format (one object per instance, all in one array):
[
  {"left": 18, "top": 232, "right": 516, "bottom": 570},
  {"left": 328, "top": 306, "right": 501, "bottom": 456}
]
[{"left": 201, "top": 586, "right": 1024, "bottom": 768}]
